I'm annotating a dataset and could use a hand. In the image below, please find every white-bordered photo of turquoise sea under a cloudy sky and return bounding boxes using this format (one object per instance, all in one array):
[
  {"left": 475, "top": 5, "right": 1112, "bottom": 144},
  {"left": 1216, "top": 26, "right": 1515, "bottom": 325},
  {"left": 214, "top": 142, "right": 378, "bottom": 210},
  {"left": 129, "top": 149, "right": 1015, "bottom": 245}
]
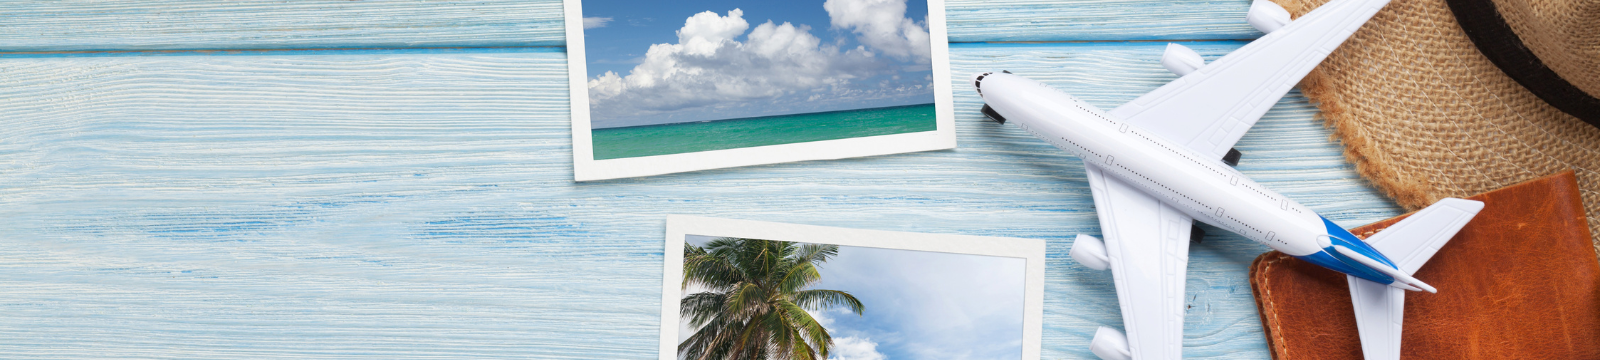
[{"left": 565, "top": 0, "right": 955, "bottom": 181}]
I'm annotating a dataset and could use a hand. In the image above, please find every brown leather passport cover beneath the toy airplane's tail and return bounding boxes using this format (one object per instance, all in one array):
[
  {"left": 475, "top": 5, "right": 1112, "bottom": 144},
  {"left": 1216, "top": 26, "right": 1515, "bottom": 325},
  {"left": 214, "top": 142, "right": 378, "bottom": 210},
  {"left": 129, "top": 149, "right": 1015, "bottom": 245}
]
[{"left": 1250, "top": 171, "right": 1600, "bottom": 360}]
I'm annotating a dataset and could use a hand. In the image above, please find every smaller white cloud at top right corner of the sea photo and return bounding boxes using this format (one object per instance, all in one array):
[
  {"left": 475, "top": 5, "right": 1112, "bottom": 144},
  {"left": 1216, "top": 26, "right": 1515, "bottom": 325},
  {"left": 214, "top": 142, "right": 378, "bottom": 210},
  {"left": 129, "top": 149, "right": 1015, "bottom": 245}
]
[{"left": 822, "top": 0, "right": 933, "bottom": 64}]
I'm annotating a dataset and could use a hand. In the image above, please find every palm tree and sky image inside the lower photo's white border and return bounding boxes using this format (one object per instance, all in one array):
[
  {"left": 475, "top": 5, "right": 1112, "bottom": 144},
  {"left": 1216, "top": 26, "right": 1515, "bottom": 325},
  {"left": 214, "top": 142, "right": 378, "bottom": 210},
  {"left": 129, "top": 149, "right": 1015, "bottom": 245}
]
[{"left": 662, "top": 235, "right": 1027, "bottom": 360}]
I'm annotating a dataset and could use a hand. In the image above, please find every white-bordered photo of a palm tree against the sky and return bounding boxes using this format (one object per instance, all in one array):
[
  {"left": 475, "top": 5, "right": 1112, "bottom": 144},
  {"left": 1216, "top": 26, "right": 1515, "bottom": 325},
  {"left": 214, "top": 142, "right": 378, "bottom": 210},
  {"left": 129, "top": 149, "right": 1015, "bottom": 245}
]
[{"left": 661, "top": 216, "right": 1045, "bottom": 360}]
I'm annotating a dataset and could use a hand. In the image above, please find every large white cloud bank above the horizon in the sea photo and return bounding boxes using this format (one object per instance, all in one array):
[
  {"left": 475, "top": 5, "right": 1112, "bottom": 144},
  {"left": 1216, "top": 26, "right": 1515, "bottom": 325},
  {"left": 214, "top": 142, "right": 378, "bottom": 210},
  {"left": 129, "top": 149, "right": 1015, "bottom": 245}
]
[{"left": 589, "top": 10, "right": 880, "bottom": 122}]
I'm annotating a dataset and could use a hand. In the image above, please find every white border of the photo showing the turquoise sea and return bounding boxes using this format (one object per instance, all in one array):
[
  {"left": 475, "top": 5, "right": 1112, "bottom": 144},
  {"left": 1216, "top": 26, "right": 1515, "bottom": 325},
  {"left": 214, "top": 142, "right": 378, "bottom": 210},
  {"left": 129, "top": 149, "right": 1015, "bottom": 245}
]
[{"left": 562, "top": 0, "right": 955, "bottom": 181}]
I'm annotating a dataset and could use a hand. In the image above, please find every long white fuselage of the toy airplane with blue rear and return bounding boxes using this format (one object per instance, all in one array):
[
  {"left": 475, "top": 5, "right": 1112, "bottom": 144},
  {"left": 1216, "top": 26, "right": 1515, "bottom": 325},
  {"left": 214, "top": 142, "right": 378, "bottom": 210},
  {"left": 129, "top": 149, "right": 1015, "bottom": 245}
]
[{"left": 973, "top": 72, "right": 1406, "bottom": 286}]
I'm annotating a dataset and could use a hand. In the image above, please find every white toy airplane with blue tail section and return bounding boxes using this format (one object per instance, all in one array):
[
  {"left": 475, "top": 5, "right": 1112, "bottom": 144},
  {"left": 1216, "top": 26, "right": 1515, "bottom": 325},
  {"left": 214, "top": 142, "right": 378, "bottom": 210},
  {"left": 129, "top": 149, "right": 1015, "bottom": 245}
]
[{"left": 973, "top": 0, "right": 1483, "bottom": 360}]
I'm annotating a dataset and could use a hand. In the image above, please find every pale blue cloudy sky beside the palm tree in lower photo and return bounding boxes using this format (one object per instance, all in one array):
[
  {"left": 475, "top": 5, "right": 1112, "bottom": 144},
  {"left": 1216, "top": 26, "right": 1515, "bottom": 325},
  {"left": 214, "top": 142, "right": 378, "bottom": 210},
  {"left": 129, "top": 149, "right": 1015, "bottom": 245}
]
[{"left": 678, "top": 235, "right": 1026, "bottom": 360}]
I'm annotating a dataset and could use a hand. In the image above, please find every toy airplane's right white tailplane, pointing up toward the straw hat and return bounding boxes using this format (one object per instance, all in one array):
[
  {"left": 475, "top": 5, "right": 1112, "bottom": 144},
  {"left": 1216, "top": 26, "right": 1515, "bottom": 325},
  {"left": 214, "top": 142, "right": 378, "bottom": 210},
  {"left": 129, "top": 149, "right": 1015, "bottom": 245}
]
[{"left": 1366, "top": 198, "right": 1483, "bottom": 280}]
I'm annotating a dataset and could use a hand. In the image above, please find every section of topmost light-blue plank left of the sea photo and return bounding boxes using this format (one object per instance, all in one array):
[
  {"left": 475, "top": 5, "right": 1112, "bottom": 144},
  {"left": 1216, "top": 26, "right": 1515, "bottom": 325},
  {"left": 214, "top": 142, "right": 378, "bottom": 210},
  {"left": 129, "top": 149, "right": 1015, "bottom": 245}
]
[{"left": 0, "top": 0, "right": 563, "bottom": 51}]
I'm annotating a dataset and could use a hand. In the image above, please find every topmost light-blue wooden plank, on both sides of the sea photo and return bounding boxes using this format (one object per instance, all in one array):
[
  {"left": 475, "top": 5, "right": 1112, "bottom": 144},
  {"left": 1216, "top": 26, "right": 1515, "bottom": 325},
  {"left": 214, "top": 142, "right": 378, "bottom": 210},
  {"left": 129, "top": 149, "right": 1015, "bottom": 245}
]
[{"left": 0, "top": 0, "right": 1261, "bottom": 51}]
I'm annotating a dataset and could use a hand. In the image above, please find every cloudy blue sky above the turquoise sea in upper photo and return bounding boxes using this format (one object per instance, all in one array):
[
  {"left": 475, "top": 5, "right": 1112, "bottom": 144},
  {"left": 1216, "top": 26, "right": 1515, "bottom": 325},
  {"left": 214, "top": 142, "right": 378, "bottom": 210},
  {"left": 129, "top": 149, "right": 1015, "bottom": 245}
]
[{"left": 582, "top": 0, "right": 933, "bottom": 128}]
